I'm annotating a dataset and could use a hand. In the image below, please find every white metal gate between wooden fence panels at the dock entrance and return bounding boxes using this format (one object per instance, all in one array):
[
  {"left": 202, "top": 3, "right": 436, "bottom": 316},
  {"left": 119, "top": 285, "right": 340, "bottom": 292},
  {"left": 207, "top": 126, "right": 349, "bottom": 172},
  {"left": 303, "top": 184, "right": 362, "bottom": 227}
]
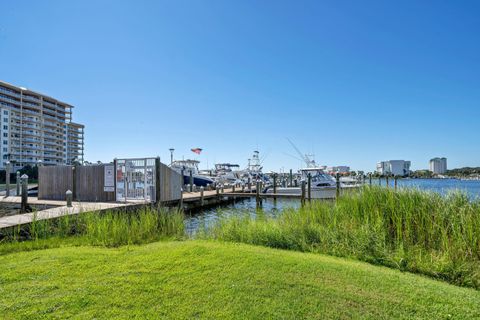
[{"left": 115, "top": 158, "right": 157, "bottom": 202}]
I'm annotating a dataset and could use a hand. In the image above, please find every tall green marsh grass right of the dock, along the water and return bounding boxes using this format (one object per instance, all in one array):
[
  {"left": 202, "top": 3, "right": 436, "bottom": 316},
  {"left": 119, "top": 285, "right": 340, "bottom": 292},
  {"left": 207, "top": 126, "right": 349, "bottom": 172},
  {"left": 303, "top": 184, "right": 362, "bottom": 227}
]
[{"left": 204, "top": 187, "right": 480, "bottom": 289}]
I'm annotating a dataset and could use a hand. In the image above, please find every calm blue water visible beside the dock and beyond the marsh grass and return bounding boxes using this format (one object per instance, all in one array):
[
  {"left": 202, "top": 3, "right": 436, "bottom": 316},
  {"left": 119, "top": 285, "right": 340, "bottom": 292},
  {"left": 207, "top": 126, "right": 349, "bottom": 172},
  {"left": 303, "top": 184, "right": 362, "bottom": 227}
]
[{"left": 185, "top": 179, "right": 480, "bottom": 234}]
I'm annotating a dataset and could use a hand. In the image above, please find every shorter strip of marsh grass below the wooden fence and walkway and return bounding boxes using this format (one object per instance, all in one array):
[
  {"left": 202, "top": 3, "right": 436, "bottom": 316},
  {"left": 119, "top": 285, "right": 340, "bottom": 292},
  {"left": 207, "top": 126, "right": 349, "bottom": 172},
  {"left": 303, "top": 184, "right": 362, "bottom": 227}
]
[{"left": 0, "top": 207, "right": 185, "bottom": 254}]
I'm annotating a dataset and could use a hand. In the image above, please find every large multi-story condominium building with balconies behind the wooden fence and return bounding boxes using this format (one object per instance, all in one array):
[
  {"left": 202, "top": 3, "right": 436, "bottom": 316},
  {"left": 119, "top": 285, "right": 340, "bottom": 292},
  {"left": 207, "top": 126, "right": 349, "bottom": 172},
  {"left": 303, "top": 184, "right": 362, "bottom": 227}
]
[{"left": 0, "top": 81, "right": 84, "bottom": 169}]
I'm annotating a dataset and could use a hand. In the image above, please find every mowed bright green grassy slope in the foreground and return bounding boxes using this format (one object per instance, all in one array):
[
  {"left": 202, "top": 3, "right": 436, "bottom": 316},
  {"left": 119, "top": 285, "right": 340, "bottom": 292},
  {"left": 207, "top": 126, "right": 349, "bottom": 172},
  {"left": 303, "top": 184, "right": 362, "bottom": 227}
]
[{"left": 0, "top": 241, "right": 480, "bottom": 319}]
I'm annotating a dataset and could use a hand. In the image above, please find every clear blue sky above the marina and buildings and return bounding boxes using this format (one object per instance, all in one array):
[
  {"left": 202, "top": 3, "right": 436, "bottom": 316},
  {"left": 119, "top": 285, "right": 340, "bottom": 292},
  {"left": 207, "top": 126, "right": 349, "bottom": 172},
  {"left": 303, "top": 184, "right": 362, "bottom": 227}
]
[{"left": 0, "top": 0, "right": 480, "bottom": 171}]
